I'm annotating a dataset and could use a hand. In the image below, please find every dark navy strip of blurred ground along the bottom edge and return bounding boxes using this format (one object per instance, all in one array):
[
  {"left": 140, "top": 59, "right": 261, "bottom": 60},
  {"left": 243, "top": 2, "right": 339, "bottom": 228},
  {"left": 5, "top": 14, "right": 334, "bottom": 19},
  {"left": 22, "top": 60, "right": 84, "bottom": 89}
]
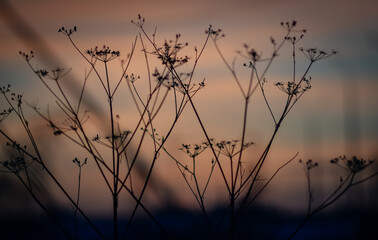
[{"left": 0, "top": 204, "right": 378, "bottom": 240}]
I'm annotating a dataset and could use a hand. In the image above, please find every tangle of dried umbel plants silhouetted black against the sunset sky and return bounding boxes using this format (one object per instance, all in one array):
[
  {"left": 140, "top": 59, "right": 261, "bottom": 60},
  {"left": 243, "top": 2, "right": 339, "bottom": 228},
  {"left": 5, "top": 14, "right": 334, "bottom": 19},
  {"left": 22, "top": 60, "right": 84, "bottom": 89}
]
[{"left": 0, "top": 15, "right": 377, "bottom": 240}]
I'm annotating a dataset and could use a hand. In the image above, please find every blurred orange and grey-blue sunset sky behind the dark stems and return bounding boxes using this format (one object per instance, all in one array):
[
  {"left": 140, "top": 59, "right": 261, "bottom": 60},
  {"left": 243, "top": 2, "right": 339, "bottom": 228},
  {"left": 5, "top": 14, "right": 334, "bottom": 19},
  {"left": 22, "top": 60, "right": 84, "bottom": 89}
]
[{"left": 0, "top": 0, "right": 378, "bottom": 239}]
